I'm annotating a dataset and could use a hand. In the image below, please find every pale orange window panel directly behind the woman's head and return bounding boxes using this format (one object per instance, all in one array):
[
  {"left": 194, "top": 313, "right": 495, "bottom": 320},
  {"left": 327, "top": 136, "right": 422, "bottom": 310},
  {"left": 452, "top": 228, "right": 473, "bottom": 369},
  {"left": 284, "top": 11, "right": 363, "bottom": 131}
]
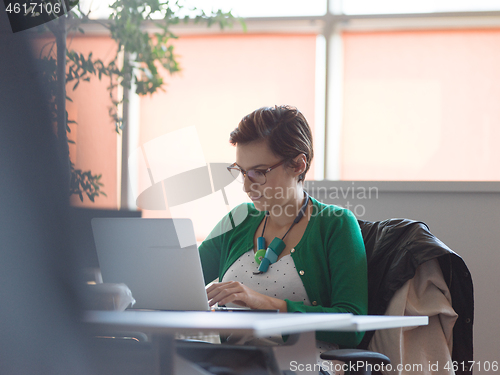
[{"left": 137, "top": 34, "right": 316, "bottom": 226}]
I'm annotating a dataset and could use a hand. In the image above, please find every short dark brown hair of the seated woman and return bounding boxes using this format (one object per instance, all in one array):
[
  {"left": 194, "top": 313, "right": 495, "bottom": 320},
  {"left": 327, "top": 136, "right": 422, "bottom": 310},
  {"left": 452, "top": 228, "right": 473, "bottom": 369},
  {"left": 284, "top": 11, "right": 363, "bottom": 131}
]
[{"left": 229, "top": 105, "right": 314, "bottom": 181}]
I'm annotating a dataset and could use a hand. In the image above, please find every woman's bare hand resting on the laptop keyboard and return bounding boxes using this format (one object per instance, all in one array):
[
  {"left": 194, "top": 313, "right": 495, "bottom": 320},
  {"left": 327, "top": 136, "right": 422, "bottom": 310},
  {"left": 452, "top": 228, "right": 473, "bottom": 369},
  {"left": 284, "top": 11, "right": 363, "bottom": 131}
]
[{"left": 207, "top": 281, "right": 287, "bottom": 312}]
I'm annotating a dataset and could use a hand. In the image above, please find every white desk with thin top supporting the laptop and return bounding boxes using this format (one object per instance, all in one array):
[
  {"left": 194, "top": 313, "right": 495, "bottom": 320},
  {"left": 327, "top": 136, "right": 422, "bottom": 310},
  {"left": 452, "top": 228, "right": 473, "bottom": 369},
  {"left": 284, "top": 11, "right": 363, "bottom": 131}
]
[{"left": 84, "top": 311, "right": 428, "bottom": 375}]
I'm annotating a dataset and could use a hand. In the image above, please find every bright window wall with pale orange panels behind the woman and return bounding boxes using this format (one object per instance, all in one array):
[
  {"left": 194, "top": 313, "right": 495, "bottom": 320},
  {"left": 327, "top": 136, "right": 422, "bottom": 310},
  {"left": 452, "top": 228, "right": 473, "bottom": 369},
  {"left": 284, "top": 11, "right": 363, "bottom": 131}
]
[{"left": 47, "top": 0, "right": 500, "bottom": 216}]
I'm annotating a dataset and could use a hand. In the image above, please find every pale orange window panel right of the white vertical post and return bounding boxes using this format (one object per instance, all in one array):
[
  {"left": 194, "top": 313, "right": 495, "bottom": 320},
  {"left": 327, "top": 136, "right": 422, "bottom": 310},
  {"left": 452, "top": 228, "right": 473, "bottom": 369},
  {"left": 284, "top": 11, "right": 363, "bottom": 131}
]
[{"left": 341, "top": 29, "right": 500, "bottom": 180}]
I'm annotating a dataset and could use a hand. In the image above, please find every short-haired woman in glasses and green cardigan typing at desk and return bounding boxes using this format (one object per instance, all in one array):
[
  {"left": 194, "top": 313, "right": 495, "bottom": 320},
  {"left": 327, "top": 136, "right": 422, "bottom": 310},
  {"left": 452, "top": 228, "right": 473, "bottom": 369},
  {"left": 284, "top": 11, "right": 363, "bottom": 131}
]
[{"left": 200, "top": 106, "right": 367, "bottom": 362}]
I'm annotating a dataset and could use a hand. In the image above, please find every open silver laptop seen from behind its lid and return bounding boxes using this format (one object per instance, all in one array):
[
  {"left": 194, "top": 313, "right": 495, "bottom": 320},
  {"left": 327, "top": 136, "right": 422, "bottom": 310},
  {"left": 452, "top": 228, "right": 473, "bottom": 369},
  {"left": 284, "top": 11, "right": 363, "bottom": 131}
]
[{"left": 92, "top": 218, "right": 210, "bottom": 311}]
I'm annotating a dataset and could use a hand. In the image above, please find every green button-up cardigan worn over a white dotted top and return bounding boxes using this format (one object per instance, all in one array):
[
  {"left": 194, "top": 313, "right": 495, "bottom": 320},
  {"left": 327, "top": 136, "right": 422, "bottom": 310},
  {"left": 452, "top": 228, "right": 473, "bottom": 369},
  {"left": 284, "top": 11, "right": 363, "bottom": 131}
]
[{"left": 200, "top": 198, "right": 368, "bottom": 348}]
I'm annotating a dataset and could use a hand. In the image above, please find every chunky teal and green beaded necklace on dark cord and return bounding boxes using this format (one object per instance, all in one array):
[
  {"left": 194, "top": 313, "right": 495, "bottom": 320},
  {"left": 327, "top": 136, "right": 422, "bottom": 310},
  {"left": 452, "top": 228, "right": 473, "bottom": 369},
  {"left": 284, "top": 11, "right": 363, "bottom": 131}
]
[{"left": 254, "top": 191, "right": 309, "bottom": 275}]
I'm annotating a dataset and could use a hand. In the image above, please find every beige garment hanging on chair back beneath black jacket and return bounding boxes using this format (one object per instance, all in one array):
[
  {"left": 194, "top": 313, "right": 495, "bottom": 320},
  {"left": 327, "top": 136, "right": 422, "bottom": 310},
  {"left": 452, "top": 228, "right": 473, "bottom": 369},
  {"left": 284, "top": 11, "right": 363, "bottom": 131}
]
[{"left": 368, "top": 259, "right": 458, "bottom": 375}]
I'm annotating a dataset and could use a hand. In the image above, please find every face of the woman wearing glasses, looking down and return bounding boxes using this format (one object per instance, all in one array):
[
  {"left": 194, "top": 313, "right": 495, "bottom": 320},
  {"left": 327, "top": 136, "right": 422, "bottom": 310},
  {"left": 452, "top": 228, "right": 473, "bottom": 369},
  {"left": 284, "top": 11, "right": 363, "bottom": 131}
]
[{"left": 236, "top": 141, "right": 298, "bottom": 212}]
